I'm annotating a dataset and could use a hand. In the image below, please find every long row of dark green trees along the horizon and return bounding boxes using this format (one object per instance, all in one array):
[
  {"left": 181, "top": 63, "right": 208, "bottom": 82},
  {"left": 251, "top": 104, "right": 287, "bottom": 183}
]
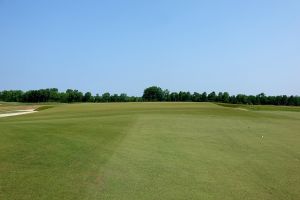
[{"left": 0, "top": 86, "right": 300, "bottom": 106}]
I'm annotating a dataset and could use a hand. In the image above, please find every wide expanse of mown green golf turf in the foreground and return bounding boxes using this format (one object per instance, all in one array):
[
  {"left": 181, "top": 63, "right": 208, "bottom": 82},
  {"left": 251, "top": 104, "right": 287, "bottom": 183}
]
[{"left": 0, "top": 103, "right": 300, "bottom": 200}]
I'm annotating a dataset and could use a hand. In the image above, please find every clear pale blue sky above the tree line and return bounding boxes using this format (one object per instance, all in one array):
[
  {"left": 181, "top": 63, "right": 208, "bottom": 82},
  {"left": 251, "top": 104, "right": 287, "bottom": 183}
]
[{"left": 0, "top": 0, "right": 300, "bottom": 95}]
